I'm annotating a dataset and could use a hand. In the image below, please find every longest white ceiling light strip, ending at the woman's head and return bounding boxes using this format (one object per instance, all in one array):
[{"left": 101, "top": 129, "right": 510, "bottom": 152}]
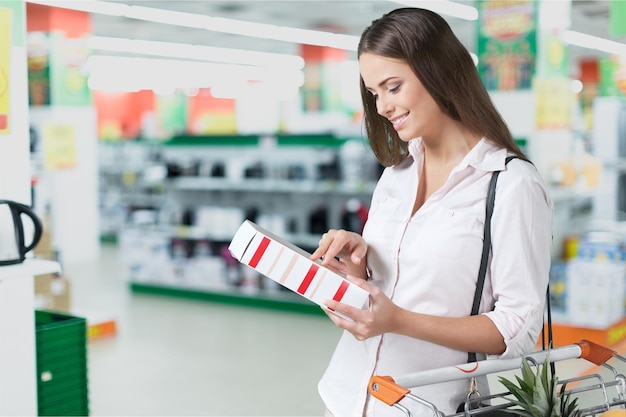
[{"left": 28, "top": 0, "right": 359, "bottom": 51}]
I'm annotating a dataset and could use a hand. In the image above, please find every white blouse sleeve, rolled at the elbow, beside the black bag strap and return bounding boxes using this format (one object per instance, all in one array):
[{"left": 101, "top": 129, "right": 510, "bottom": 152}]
[{"left": 484, "top": 161, "right": 553, "bottom": 358}]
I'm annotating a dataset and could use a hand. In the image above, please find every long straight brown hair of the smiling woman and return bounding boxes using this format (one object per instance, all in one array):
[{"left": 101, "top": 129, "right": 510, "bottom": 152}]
[{"left": 358, "top": 7, "right": 527, "bottom": 166}]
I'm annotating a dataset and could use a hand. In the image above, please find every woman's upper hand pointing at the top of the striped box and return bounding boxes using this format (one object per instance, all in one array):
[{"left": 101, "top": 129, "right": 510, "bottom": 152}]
[{"left": 311, "top": 229, "right": 367, "bottom": 279}]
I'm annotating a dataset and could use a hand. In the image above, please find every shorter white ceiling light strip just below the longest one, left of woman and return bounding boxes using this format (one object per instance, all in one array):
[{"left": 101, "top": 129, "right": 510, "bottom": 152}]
[{"left": 87, "top": 36, "right": 304, "bottom": 69}]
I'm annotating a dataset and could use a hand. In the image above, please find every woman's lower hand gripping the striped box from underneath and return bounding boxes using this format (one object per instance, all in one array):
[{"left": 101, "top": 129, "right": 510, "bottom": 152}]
[{"left": 324, "top": 276, "right": 404, "bottom": 341}]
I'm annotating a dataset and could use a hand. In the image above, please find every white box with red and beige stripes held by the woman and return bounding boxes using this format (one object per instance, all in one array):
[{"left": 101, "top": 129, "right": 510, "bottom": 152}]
[{"left": 228, "top": 220, "right": 369, "bottom": 314}]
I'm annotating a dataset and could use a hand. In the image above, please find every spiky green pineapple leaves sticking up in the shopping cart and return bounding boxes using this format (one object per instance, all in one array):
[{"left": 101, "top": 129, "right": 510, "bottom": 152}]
[{"left": 499, "top": 355, "right": 579, "bottom": 417}]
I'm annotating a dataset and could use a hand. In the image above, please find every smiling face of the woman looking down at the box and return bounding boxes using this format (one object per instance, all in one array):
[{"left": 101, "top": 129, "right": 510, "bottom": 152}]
[{"left": 359, "top": 53, "right": 446, "bottom": 141}]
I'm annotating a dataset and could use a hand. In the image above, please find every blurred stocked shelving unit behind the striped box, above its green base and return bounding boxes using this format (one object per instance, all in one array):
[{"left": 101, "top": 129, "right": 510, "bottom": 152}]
[{"left": 99, "top": 135, "right": 381, "bottom": 308}]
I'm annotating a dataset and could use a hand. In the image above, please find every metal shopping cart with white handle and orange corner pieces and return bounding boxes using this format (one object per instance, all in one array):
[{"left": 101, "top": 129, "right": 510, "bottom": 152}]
[{"left": 368, "top": 340, "right": 626, "bottom": 417}]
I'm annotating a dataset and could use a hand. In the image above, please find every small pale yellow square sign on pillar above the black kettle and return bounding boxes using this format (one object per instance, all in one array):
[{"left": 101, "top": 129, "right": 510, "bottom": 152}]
[{"left": 42, "top": 124, "right": 76, "bottom": 170}]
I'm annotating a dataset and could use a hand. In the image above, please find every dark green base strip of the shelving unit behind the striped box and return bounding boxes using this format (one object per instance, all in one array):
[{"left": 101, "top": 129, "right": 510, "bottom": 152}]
[{"left": 130, "top": 282, "right": 325, "bottom": 315}]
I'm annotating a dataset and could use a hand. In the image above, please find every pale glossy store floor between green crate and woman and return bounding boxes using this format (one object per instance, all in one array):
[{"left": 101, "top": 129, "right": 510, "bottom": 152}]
[{"left": 65, "top": 245, "right": 611, "bottom": 416}]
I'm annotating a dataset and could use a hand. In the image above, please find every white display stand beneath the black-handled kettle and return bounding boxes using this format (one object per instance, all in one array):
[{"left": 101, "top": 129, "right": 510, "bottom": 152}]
[{"left": 0, "top": 259, "right": 61, "bottom": 416}]
